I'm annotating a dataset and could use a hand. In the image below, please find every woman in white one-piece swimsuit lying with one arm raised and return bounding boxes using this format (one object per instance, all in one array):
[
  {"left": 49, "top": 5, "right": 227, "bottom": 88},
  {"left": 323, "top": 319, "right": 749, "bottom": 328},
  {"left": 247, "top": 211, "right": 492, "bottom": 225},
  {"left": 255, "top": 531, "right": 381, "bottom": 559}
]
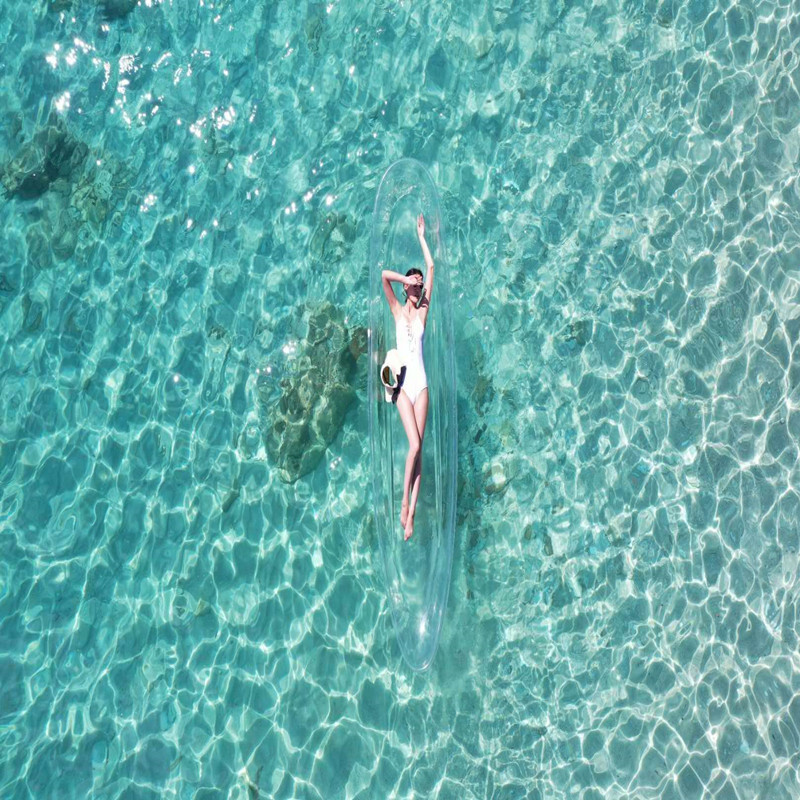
[{"left": 381, "top": 214, "right": 433, "bottom": 541}]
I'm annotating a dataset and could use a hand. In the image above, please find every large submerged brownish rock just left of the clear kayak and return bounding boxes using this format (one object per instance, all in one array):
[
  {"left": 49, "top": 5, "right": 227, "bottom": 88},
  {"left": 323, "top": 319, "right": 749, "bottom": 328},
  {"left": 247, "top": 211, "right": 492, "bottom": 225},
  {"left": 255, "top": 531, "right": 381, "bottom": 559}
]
[{"left": 258, "top": 301, "right": 367, "bottom": 483}]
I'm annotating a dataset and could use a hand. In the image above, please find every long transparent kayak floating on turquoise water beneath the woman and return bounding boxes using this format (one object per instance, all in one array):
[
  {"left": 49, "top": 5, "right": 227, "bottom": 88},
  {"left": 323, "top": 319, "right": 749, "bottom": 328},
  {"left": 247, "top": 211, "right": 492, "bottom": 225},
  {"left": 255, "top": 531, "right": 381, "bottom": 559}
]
[{"left": 368, "top": 158, "right": 458, "bottom": 671}]
